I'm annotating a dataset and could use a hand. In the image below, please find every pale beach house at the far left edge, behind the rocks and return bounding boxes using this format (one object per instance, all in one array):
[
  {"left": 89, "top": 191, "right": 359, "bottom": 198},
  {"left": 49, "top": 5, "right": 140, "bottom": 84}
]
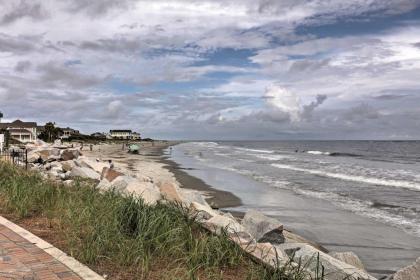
[{"left": 0, "top": 120, "right": 37, "bottom": 143}]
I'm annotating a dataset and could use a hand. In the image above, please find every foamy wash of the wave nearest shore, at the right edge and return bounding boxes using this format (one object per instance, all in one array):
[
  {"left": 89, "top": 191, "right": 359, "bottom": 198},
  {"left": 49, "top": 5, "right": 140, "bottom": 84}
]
[{"left": 295, "top": 189, "right": 420, "bottom": 236}]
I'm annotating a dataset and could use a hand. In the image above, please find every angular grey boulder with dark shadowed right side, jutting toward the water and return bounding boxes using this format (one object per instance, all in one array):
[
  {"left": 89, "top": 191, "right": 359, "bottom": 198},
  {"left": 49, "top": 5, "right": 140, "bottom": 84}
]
[{"left": 242, "top": 210, "right": 284, "bottom": 244}]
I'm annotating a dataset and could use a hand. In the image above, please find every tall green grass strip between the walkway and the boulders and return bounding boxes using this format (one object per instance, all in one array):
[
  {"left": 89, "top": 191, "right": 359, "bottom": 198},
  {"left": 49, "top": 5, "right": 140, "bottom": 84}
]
[{"left": 0, "top": 162, "right": 322, "bottom": 280}]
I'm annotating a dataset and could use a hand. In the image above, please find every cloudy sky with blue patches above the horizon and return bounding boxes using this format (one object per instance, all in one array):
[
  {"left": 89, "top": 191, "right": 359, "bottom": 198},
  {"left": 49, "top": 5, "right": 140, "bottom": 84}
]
[{"left": 0, "top": 0, "right": 420, "bottom": 140}]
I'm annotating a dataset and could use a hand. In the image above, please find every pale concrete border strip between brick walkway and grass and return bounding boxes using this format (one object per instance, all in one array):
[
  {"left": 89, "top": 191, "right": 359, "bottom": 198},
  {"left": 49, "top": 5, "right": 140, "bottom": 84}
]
[{"left": 0, "top": 216, "right": 105, "bottom": 280}]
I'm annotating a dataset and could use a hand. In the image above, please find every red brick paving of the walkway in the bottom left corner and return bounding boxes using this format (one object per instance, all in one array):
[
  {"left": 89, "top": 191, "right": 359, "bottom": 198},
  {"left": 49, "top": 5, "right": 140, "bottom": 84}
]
[{"left": 0, "top": 225, "right": 82, "bottom": 280}]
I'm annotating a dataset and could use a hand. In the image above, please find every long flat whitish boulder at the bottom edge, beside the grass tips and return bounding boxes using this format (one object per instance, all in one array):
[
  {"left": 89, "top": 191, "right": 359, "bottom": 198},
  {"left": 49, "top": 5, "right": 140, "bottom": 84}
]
[{"left": 275, "top": 243, "right": 376, "bottom": 280}]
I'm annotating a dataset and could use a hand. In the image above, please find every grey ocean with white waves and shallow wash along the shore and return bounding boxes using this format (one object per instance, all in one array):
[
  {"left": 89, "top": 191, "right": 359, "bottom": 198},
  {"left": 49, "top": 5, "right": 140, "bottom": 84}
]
[{"left": 171, "top": 141, "right": 420, "bottom": 271}]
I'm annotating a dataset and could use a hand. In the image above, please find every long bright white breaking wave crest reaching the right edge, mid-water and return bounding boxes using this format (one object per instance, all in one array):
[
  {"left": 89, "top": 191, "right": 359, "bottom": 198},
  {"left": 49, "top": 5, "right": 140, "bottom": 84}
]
[{"left": 271, "top": 163, "right": 420, "bottom": 191}]
